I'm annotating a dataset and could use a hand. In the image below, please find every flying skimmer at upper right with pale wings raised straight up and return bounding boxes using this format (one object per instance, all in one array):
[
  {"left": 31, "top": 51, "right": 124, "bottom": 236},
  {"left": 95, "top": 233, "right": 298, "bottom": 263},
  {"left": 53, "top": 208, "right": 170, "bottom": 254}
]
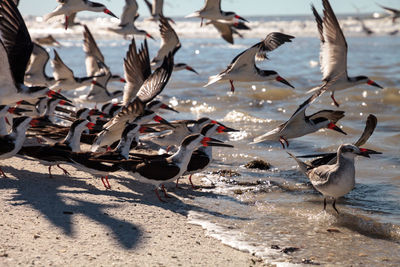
[{"left": 308, "top": 0, "right": 382, "bottom": 106}]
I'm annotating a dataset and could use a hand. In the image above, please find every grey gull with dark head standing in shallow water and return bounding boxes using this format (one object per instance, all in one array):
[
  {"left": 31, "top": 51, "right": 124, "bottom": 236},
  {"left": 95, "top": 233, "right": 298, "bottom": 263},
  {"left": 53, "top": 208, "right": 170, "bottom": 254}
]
[{"left": 287, "top": 144, "right": 374, "bottom": 213}]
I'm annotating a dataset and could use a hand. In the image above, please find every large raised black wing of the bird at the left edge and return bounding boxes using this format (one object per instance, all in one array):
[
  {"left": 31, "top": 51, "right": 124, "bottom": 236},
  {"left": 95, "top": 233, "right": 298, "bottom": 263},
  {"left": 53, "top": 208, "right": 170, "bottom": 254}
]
[{"left": 0, "top": 0, "right": 33, "bottom": 84}]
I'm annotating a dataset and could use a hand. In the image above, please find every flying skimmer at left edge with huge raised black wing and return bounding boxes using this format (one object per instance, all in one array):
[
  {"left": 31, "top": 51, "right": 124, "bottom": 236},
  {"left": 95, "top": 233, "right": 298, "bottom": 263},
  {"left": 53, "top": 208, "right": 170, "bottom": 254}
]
[{"left": 0, "top": 0, "right": 67, "bottom": 105}]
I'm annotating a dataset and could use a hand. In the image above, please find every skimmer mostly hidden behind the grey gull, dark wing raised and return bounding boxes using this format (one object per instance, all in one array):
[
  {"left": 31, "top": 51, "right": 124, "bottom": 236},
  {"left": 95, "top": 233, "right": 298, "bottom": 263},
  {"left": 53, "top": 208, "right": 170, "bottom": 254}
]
[{"left": 297, "top": 114, "right": 382, "bottom": 168}]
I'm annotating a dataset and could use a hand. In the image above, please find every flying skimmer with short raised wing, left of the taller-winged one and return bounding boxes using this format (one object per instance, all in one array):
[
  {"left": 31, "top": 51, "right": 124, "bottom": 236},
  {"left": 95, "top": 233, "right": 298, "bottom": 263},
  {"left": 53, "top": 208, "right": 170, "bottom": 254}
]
[{"left": 50, "top": 50, "right": 105, "bottom": 90}]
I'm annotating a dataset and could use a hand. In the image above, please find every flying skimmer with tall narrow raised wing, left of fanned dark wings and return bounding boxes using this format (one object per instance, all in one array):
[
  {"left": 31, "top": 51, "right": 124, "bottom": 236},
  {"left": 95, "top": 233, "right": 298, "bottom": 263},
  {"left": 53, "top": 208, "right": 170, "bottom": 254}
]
[{"left": 83, "top": 25, "right": 126, "bottom": 83}]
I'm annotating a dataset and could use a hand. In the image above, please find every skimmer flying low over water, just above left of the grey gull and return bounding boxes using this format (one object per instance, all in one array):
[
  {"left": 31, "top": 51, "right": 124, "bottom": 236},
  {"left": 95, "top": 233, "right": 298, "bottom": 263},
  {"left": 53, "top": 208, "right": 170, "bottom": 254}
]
[{"left": 251, "top": 80, "right": 346, "bottom": 148}]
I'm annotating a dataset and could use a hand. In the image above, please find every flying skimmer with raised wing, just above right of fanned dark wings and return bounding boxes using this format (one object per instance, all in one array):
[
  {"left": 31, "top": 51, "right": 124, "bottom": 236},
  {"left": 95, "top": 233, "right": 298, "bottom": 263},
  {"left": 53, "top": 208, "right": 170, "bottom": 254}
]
[{"left": 151, "top": 16, "right": 198, "bottom": 74}]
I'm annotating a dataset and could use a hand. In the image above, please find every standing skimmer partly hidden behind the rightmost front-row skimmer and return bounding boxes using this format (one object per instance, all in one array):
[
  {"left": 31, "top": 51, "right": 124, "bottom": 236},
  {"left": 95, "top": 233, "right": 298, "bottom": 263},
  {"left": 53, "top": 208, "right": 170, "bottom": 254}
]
[{"left": 181, "top": 123, "right": 237, "bottom": 188}]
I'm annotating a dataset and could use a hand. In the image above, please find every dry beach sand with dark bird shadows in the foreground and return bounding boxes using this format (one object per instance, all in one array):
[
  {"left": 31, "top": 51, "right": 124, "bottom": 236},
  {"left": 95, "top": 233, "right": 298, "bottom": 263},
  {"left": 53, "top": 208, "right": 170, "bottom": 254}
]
[{"left": 0, "top": 158, "right": 263, "bottom": 266}]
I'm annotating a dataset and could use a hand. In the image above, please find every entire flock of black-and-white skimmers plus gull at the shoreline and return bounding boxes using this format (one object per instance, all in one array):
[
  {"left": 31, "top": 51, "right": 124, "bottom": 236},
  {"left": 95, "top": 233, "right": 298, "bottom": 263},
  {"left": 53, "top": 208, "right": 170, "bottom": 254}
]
[{"left": 0, "top": 0, "right": 398, "bottom": 214}]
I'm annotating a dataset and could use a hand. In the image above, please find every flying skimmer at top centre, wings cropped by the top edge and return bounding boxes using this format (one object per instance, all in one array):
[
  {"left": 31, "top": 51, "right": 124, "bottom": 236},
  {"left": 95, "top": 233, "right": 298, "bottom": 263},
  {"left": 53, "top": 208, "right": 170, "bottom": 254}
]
[{"left": 185, "top": 0, "right": 248, "bottom": 26}]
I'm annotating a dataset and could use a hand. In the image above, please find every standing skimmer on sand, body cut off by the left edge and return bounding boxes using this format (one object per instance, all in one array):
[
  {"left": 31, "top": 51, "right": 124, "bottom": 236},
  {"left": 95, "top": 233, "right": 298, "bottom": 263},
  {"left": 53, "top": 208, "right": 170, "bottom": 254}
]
[{"left": 0, "top": 116, "right": 38, "bottom": 177}]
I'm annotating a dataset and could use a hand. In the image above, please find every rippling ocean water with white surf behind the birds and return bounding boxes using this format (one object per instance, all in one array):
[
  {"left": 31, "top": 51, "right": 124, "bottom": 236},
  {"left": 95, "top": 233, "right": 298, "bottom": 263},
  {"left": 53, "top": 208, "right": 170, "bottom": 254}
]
[{"left": 27, "top": 15, "right": 400, "bottom": 266}]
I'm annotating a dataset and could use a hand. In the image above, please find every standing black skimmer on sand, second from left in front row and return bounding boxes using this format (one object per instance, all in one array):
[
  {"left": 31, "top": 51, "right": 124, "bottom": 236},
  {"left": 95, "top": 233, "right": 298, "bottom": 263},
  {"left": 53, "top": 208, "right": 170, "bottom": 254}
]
[{"left": 18, "top": 119, "right": 95, "bottom": 177}]
